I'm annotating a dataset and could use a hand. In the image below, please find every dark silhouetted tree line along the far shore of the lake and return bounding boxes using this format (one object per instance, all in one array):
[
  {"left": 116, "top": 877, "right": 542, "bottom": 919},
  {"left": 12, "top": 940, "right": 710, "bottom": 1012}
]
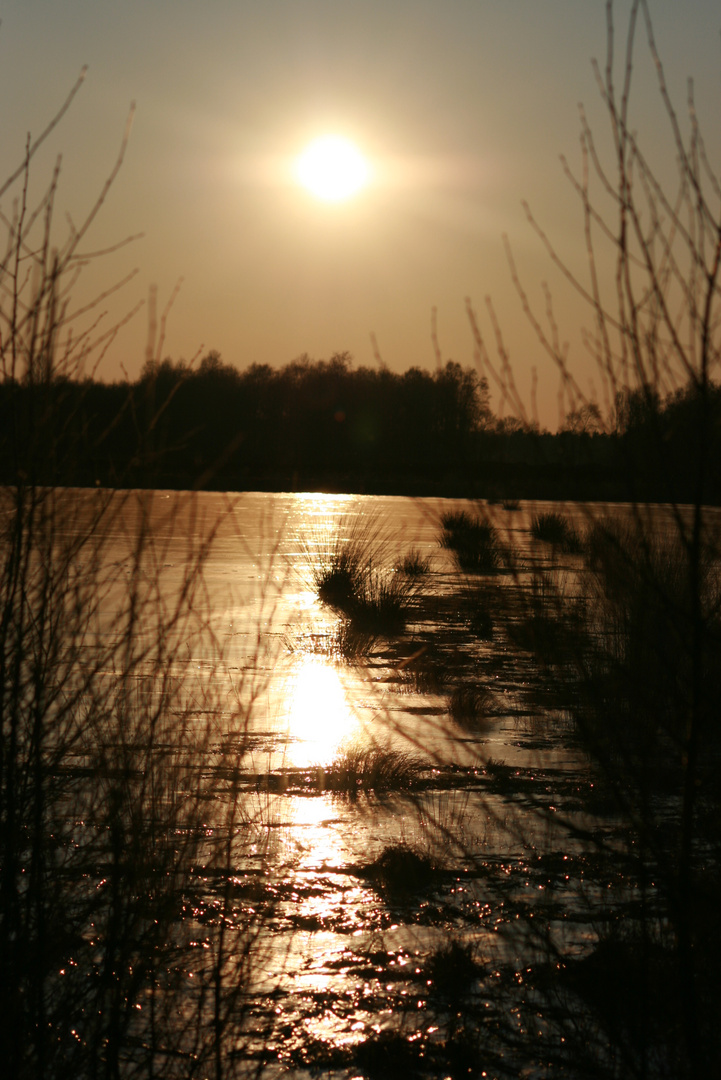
[{"left": 0, "top": 352, "right": 721, "bottom": 503}]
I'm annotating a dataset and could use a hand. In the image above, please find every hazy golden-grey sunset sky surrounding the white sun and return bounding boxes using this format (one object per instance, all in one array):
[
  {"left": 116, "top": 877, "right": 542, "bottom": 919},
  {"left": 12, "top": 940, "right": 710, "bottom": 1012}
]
[{"left": 0, "top": 0, "right": 721, "bottom": 427}]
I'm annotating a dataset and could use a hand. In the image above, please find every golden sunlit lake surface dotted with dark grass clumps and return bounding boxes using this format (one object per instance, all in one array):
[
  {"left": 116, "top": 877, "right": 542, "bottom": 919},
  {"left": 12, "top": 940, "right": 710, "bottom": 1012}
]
[{"left": 16, "top": 491, "right": 708, "bottom": 1077}]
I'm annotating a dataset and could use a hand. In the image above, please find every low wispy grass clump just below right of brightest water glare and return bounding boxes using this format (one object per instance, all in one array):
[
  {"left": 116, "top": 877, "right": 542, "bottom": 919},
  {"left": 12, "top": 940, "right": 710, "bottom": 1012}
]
[{"left": 323, "top": 744, "right": 422, "bottom": 798}]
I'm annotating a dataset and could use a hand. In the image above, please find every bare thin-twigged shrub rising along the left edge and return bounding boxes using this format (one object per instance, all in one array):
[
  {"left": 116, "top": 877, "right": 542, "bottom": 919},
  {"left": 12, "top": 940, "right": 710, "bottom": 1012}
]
[{"left": 0, "top": 73, "right": 262, "bottom": 1078}]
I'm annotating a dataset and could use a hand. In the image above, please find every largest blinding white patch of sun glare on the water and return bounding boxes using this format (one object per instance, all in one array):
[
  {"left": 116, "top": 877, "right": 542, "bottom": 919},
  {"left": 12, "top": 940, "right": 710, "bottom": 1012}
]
[{"left": 288, "top": 656, "right": 358, "bottom": 768}]
